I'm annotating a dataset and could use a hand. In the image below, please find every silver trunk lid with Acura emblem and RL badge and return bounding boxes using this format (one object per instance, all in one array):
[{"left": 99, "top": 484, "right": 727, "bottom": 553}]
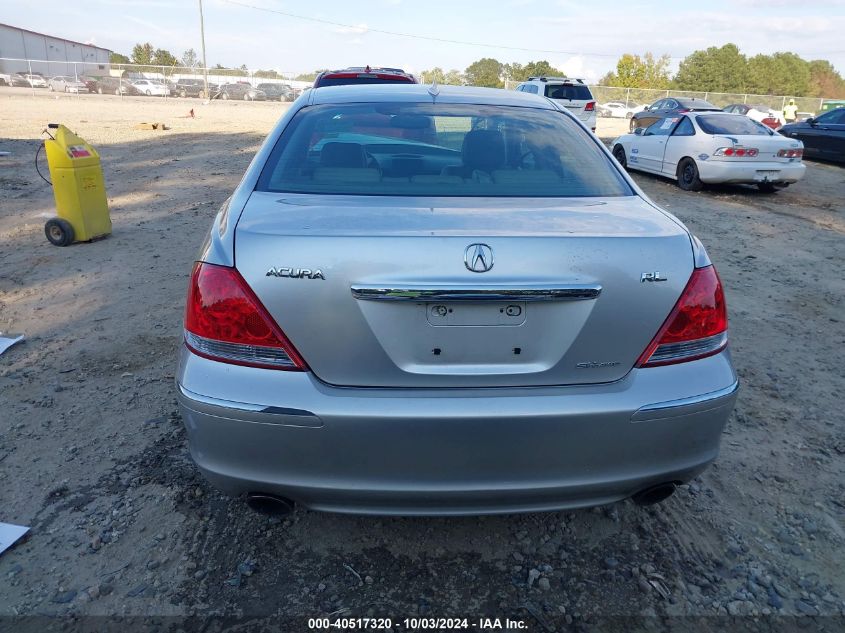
[{"left": 235, "top": 192, "right": 693, "bottom": 387}]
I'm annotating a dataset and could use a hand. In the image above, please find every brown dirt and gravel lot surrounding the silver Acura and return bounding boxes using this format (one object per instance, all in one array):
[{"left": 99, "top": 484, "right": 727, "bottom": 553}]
[{"left": 0, "top": 93, "right": 845, "bottom": 631}]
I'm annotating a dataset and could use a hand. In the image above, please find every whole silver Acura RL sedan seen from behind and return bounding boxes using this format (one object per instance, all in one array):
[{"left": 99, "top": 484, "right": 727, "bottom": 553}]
[{"left": 177, "top": 84, "right": 737, "bottom": 515}]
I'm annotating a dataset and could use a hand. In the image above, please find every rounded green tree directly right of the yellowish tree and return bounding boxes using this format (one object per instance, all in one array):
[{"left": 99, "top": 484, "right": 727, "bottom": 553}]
[{"left": 674, "top": 44, "right": 749, "bottom": 92}]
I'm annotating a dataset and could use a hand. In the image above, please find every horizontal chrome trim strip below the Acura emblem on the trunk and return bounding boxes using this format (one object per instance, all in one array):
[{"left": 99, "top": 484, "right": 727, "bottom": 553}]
[{"left": 351, "top": 284, "right": 601, "bottom": 302}]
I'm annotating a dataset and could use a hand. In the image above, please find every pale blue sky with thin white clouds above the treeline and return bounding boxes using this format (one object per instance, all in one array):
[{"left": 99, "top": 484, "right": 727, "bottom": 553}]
[{"left": 0, "top": 0, "right": 845, "bottom": 82}]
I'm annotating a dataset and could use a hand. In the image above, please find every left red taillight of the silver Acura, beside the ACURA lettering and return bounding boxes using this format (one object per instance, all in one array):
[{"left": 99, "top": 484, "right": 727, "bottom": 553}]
[{"left": 185, "top": 262, "right": 308, "bottom": 371}]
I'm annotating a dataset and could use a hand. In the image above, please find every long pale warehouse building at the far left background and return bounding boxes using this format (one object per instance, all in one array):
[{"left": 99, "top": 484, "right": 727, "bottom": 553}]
[{"left": 0, "top": 24, "right": 111, "bottom": 77}]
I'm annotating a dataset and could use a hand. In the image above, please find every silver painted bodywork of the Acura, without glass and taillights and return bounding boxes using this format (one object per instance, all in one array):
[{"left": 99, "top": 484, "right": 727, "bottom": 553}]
[{"left": 176, "top": 85, "right": 737, "bottom": 514}]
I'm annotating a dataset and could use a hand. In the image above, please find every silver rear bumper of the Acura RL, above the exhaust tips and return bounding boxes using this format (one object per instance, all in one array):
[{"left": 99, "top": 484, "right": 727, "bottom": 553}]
[{"left": 177, "top": 349, "right": 737, "bottom": 515}]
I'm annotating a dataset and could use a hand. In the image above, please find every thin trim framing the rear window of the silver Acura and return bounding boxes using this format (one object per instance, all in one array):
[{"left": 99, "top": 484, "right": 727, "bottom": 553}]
[{"left": 252, "top": 99, "right": 640, "bottom": 200}]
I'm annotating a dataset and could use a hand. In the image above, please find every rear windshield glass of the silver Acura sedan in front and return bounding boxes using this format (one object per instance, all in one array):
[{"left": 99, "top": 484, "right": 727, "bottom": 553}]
[{"left": 256, "top": 103, "right": 632, "bottom": 197}]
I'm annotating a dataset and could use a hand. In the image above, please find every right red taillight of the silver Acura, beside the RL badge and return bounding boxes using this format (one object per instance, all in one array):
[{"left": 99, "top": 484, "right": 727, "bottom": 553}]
[{"left": 637, "top": 266, "right": 728, "bottom": 367}]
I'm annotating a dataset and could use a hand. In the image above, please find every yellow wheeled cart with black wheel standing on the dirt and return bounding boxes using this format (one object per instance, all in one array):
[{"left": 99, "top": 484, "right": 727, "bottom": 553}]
[{"left": 42, "top": 123, "right": 111, "bottom": 246}]
